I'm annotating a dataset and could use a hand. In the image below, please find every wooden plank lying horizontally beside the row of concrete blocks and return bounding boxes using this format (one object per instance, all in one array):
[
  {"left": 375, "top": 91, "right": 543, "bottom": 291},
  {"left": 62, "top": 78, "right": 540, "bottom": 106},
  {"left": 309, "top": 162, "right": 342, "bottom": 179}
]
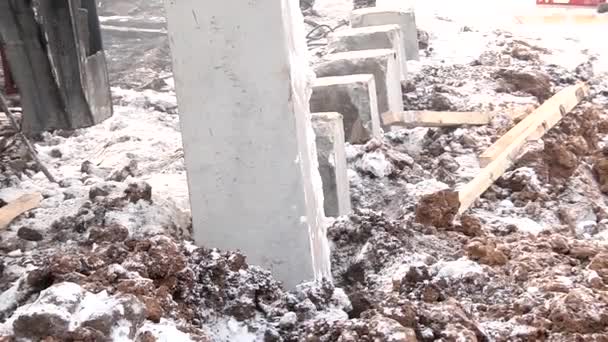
[{"left": 382, "top": 111, "right": 491, "bottom": 127}]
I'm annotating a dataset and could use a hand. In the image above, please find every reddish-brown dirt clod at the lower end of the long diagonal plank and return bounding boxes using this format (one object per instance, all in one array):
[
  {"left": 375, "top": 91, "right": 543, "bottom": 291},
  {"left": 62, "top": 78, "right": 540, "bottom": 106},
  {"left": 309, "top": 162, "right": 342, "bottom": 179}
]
[{"left": 416, "top": 190, "right": 460, "bottom": 227}]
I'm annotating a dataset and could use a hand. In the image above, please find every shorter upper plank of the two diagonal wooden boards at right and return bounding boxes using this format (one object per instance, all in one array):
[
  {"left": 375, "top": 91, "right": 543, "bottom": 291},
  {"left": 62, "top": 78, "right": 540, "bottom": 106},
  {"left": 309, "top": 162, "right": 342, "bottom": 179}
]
[{"left": 479, "top": 83, "right": 589, "bottom": 167}]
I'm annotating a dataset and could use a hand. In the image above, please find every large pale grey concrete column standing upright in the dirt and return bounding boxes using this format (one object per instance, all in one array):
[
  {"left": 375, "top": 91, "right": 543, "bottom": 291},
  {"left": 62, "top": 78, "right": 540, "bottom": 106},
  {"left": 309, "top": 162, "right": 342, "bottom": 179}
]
[{"left": 166, "top": 0, "right": 331, "bottom": 287}]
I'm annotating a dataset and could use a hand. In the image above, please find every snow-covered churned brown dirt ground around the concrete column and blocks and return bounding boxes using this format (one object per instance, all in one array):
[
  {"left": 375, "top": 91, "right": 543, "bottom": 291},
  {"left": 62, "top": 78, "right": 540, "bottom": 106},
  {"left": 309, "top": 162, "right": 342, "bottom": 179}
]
[{"left": 0, "top": 0, "right": 608, "bottom": 342}]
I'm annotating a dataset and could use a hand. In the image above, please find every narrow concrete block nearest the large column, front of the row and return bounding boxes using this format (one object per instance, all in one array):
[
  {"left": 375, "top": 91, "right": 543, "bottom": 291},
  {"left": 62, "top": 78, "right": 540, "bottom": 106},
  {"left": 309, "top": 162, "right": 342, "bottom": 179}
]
[{"left": 312, "top": 113, "right": 351, "bottom": 217}]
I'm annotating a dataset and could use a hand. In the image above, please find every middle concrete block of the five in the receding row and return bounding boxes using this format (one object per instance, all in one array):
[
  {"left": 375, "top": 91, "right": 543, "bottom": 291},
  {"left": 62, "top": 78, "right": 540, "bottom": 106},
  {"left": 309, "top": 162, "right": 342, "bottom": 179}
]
[{"left": 315, "top": 49, "right": 403, "bottom": 119}]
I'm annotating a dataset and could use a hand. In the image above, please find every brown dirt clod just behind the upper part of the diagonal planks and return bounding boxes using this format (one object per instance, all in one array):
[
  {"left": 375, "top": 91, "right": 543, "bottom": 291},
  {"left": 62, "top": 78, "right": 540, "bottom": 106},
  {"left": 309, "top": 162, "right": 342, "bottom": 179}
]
[{"left": 494, "top": 69, "right": 553, "bottom": 103}]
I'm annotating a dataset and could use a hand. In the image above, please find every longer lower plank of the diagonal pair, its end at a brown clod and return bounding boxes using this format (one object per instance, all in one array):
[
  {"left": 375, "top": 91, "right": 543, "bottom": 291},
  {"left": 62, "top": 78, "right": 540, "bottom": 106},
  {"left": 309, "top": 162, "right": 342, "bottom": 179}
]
[{"left": 458, "top": 83, "right": 589, "bottom": 214}]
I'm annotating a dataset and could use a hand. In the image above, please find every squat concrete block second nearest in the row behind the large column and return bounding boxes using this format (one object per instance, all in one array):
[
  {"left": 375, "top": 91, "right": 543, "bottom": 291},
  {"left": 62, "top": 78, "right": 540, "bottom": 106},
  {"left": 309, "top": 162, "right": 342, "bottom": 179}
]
[{"left": 310, "top": 74, "right": 382, "bottom": 144}]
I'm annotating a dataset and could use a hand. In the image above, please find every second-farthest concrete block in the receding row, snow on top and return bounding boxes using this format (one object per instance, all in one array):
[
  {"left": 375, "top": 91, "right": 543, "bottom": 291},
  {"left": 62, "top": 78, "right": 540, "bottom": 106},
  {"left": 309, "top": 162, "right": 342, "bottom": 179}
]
[{"left": 327, "top": 25, "right": 407, "bottom": 81}]
